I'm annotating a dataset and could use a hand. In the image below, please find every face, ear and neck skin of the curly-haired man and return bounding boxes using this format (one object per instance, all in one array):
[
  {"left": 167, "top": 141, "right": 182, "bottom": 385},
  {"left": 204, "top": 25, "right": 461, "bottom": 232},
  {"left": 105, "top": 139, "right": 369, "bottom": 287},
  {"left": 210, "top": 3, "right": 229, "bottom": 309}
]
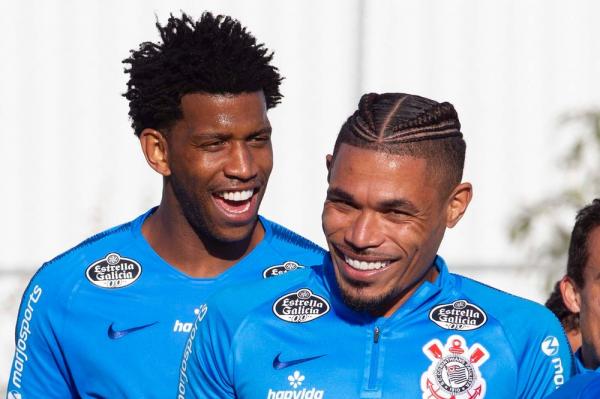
[{"left": 140, "top": 91, "right": 273, "bottom": 278}]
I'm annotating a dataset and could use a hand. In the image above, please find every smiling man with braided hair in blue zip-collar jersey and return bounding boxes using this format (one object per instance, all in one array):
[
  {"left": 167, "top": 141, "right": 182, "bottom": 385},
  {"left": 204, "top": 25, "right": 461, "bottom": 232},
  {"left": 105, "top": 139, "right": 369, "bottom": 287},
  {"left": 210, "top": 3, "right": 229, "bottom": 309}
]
[{"left": 180, "top": 93, "right": 572, "bottom": 399}]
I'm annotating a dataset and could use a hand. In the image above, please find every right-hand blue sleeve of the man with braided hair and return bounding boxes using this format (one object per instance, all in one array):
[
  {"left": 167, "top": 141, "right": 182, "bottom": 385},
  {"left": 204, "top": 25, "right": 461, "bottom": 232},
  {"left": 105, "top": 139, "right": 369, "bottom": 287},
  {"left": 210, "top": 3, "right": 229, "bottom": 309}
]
[{"left": 519, "top": 308, "right": 573, "bottom": 399}]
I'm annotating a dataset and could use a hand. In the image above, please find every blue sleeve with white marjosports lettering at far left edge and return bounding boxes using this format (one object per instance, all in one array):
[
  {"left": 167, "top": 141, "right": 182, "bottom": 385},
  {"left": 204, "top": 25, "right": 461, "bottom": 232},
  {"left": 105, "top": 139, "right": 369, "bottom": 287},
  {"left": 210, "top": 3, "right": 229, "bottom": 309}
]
[{"left": 7, "top": 272, "right": 74, "bottom": 399}]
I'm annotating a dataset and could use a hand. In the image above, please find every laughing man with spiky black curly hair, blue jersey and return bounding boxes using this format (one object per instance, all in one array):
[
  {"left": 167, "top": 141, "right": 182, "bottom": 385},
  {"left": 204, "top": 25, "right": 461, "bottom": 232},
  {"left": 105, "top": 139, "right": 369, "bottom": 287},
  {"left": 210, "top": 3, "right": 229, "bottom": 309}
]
[{"left": 8, "top": 13, "right": 324, "bottom": 399}]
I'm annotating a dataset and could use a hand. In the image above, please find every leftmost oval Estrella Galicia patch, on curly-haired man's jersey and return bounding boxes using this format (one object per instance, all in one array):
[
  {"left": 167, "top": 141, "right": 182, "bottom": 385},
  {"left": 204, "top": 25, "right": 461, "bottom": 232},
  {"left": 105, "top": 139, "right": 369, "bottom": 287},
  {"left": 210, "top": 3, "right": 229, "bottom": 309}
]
[{"left": 85, "top": 252, "right": 142, "bottom": 288}]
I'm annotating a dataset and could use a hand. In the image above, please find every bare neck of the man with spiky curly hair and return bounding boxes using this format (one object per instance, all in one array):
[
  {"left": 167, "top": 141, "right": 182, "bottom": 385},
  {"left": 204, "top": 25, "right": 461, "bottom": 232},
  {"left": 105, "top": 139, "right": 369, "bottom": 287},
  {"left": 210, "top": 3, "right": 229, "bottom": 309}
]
[{"left": 142, "top": 195, "right": 265, "bottom": 278}]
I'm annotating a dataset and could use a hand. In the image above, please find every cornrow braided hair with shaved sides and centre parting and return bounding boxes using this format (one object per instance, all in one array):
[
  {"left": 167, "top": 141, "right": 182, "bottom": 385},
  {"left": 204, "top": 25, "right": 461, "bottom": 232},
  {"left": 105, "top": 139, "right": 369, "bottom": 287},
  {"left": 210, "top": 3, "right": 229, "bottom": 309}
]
[{"left": 333, "top": 93, "right": 466, "bottom": 195}]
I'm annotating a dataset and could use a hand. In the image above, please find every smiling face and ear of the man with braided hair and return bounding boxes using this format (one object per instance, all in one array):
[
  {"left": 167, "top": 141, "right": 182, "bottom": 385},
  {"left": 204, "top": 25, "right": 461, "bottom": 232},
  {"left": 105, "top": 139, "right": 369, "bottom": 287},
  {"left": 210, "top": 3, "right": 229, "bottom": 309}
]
[{"left": 323, "top": 144, "right": 471, "bottom": 315}]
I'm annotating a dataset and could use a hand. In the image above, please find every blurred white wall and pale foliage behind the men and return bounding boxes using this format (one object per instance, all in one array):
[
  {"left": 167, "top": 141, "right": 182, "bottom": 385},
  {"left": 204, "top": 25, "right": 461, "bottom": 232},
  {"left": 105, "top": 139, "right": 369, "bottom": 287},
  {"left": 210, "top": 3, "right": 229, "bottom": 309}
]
[{"left": 0, "top": 0, "right": 600, "bottom": 395}]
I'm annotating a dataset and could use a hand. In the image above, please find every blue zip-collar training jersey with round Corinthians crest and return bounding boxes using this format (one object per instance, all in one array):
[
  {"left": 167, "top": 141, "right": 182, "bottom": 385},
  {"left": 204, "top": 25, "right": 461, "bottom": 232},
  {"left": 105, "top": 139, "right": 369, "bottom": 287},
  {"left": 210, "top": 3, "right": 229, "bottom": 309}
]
[{"left": 185, "top": 257, "right": 572, "bottom": 399}]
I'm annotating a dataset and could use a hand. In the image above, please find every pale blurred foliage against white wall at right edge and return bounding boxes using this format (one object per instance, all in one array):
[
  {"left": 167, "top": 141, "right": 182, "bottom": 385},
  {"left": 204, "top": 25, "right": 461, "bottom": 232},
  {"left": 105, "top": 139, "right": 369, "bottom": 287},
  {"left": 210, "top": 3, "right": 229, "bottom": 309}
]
[{"left": 509, "top": 110, "right": 600, "bottom": 271}]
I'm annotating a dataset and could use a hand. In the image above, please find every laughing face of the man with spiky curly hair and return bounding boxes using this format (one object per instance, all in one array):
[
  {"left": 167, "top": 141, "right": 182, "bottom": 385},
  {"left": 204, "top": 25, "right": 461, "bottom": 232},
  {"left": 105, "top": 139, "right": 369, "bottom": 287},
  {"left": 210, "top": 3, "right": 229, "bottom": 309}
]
[{"left": 166, "top": 92, "right": 273, "bottom": 242}]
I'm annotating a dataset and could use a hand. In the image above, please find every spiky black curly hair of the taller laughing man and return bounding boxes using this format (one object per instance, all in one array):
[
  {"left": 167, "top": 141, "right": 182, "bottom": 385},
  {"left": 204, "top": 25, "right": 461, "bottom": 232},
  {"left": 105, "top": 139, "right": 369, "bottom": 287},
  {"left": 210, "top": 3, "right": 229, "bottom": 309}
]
[{"left": 123, "top": 12, "right": 282, "bottom": 136}]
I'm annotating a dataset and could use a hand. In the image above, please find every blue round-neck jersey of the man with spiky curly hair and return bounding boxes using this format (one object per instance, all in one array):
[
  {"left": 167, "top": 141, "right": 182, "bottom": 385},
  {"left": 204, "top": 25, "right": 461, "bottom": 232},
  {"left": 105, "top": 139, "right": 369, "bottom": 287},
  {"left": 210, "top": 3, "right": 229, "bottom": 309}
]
[{"left": 7, "top": 210, "right": 325, "bottom": 399}]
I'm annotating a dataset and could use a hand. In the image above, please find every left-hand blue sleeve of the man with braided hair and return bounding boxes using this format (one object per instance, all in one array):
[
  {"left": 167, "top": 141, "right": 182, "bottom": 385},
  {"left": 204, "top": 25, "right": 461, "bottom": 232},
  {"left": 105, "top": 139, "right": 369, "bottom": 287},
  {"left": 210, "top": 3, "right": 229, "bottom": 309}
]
[{"left": 177, "top": 303, "right": 235, "bottom": 399}]
